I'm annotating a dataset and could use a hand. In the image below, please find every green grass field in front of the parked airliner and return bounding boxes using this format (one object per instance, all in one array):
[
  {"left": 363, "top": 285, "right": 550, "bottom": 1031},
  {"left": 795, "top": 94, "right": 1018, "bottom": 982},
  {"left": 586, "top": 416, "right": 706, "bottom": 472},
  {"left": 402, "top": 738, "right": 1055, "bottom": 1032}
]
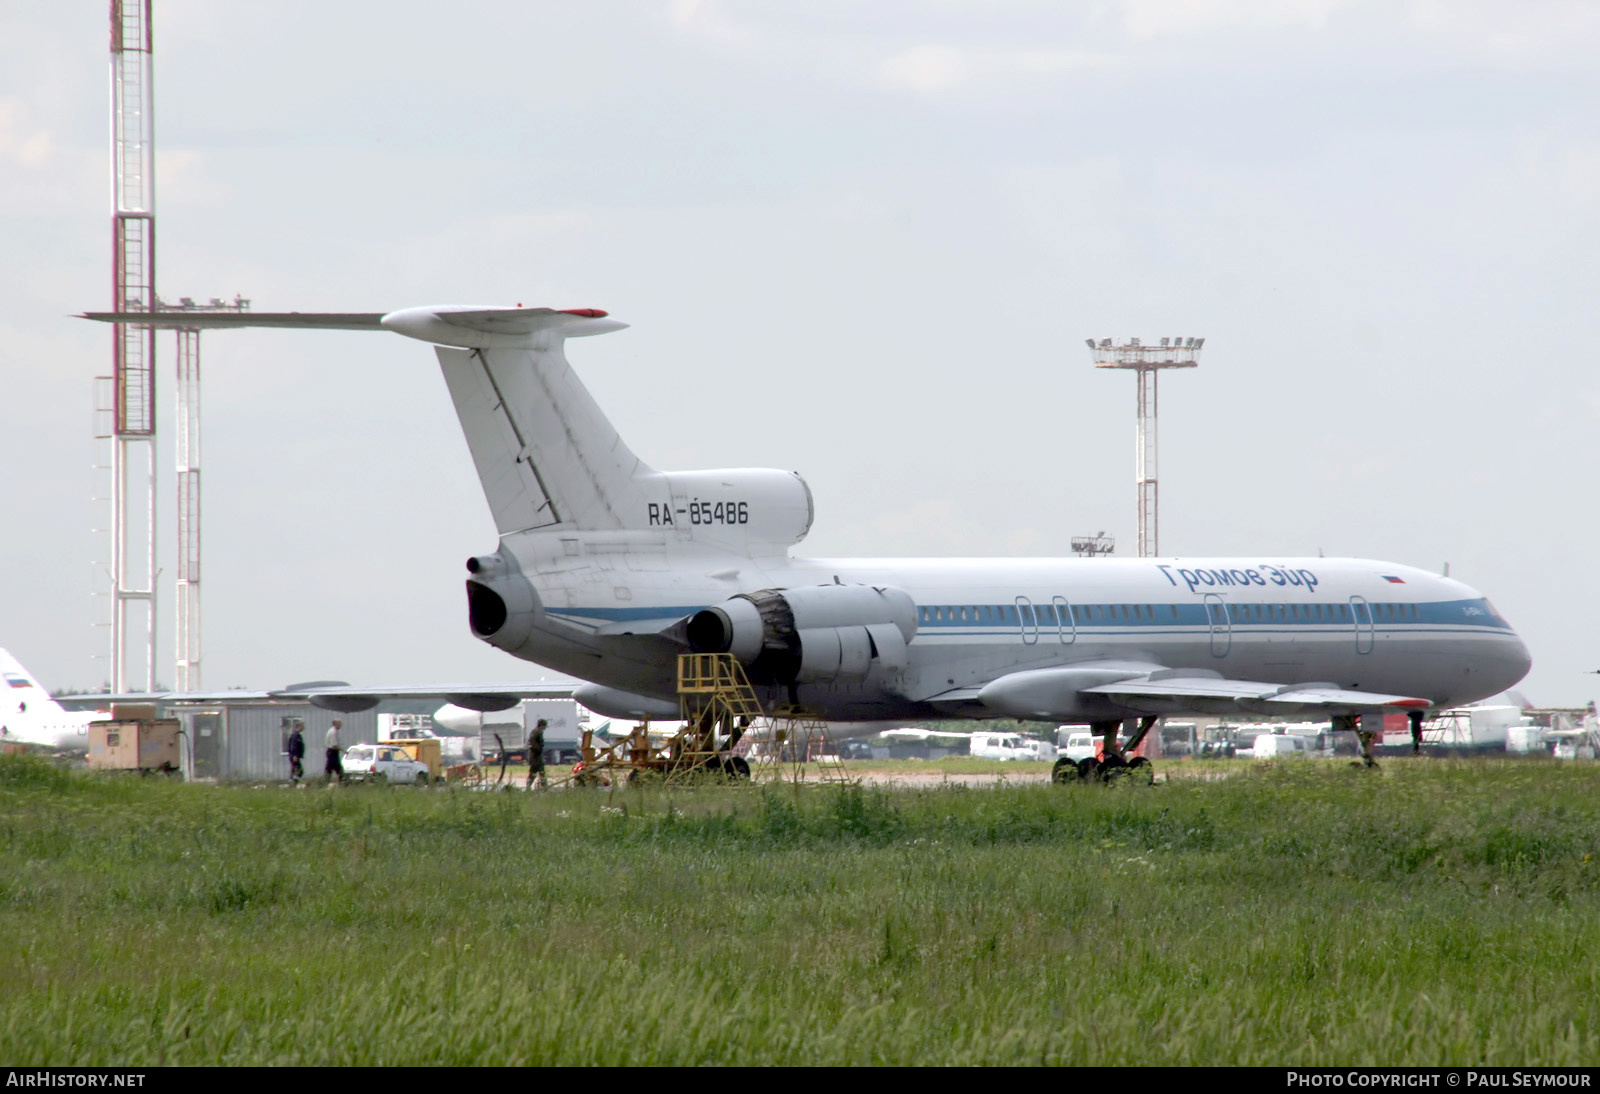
[{"left": 0, "top": 757, "right": 1600, "bottom": 1065}]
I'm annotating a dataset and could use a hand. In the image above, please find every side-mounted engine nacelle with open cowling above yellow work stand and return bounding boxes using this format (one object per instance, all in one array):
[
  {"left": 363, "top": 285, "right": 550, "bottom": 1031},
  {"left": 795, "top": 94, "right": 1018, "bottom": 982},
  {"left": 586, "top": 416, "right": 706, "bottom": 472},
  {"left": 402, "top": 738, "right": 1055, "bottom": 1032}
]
[{"left": 688, "top": 585, "right": 917, "bottom": 685}]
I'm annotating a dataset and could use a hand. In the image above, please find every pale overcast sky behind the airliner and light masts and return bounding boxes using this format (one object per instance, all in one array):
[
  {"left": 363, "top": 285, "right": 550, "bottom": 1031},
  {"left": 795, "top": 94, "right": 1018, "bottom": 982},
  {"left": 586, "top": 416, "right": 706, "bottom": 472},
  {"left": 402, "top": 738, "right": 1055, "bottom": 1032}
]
[{"left": 0, "top": 0, "right": 1600, "bottom": 705}]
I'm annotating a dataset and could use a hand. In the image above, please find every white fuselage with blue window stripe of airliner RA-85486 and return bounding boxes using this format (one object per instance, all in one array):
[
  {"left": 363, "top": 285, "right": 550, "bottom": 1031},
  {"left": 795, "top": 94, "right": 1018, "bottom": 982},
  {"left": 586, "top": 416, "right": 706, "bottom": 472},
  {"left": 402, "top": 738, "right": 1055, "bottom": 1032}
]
[{"left": 480, "top": 543, "right": 1530, "bottom": 720}]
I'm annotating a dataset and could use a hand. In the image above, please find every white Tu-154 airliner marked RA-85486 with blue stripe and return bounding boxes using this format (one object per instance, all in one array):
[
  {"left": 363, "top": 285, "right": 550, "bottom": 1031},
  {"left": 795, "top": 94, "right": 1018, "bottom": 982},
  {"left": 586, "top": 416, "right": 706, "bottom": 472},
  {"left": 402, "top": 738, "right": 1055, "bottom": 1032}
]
[{"left": 90, "top": 305, "right": 1530, "bottom": 774}]
